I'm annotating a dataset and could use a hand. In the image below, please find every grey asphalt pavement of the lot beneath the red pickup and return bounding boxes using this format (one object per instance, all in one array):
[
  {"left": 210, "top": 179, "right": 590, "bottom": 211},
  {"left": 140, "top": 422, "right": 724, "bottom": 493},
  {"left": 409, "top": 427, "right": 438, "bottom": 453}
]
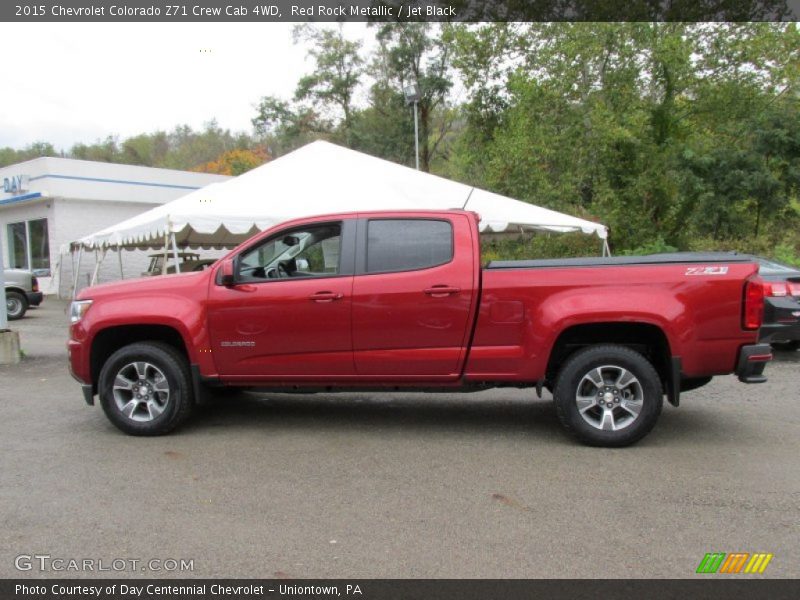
[{"left": 0, "top": 298, "right": 800, "bottom": 578}]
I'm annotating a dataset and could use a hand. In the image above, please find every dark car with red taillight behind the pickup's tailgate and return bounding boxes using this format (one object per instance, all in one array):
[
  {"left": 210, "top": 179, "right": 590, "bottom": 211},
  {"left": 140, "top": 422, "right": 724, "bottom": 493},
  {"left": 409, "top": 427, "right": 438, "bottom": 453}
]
[{"left": 758, "top": 257, "right": 800, "bottom": 350}]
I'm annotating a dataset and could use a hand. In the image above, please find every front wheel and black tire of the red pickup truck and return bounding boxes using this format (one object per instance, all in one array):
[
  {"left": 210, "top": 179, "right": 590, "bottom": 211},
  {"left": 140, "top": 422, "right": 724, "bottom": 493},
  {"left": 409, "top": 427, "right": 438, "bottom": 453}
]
[{"left": 97, "top": 341, "right": 193, "bottom": 435}]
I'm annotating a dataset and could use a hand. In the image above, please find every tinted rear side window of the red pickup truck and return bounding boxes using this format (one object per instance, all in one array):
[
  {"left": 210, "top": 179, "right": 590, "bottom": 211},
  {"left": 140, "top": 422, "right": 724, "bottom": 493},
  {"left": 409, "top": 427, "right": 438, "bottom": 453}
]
[{"left": 366, "top": 219, "right": 453, "bottom": 273}]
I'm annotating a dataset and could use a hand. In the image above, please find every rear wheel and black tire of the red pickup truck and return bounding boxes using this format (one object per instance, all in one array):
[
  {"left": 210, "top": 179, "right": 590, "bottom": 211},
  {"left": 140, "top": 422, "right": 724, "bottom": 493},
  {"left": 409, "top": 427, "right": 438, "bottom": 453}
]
[{"left": 553, "top": 345, "right": 664, "bottom": 448}]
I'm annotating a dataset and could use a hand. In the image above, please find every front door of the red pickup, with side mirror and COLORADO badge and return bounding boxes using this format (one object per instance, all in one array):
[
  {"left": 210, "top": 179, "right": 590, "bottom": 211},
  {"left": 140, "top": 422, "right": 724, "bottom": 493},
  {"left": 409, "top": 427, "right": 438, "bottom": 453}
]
[{"left": 208, "top": 219, "right": 356, "bottom": 381}]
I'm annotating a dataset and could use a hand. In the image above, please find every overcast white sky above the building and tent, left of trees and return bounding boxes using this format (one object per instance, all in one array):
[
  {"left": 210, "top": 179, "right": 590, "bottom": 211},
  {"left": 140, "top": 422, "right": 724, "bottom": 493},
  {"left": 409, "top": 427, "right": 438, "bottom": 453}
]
[{"left": 0, "top": 23, "right": 373, "bottom": 150}]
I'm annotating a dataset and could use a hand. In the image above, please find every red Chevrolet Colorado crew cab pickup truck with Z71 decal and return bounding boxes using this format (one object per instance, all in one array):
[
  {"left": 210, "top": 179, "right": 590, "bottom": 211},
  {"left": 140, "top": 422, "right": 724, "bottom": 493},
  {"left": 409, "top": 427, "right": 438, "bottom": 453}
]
[{"left": 68, "top": 210, "right": 771, "bottom": 446}]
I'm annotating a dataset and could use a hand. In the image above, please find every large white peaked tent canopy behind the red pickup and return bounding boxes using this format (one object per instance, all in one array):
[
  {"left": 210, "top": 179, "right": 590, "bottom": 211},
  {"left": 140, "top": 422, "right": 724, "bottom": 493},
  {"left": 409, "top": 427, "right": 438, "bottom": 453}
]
[{"left": 69, "top": 141, "right": 608, "bottom": 251}]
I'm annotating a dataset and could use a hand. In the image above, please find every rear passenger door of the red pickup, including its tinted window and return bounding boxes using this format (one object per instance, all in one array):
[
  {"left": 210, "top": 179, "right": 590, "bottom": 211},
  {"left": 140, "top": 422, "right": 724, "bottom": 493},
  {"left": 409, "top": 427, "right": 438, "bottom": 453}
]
[{"left": 353, "top": 214, "right": 476, "bottom": 379}]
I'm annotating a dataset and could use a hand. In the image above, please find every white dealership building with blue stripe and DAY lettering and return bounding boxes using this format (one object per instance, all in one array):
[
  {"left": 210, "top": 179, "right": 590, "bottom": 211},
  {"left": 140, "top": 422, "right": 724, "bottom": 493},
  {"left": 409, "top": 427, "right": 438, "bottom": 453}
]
[{"left": 0, "top": 158, "right": 229, "bottom": 294}]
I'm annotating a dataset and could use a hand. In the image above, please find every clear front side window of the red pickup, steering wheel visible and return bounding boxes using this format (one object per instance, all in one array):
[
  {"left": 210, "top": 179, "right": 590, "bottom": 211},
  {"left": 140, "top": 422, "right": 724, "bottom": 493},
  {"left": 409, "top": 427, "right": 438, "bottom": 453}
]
[{"left": 236, "top": 223, "right": 342, "bottom": 281}]
